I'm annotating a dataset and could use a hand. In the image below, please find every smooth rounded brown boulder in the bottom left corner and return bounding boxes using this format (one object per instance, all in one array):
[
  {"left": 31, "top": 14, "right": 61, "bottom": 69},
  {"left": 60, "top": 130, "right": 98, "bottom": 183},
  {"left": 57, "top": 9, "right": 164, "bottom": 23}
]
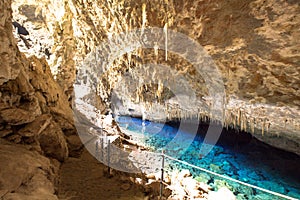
[{"left": 0, "top": 139, "right": 57, "bottom": 200}]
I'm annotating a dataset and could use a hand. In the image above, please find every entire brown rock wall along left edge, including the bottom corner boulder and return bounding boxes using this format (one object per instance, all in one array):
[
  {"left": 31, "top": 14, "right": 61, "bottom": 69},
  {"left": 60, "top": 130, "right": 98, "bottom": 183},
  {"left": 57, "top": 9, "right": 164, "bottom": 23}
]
[{"left": 0, "top": 0, "right": 76, "bottom": 199}]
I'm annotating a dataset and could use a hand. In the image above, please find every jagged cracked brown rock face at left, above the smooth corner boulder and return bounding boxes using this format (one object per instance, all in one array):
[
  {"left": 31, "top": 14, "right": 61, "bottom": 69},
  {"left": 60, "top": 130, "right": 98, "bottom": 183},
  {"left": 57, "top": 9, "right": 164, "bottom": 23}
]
[{"left": 0, "top": 1, "right": 75, "bottom": 155}]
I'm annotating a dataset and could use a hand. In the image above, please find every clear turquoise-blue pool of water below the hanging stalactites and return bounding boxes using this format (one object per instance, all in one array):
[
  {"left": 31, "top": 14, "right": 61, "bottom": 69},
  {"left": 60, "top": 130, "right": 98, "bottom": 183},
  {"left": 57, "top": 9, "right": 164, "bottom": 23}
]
[{"left": 117, "top": 116, "right": 300, "bottom": 200}]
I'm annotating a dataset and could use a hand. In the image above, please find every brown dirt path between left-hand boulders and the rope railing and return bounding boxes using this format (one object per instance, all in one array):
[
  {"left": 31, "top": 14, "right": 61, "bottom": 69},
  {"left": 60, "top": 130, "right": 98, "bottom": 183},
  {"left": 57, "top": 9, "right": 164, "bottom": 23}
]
[{"left": 58, "top": 149, "right": 148, "bottom": 200}]
